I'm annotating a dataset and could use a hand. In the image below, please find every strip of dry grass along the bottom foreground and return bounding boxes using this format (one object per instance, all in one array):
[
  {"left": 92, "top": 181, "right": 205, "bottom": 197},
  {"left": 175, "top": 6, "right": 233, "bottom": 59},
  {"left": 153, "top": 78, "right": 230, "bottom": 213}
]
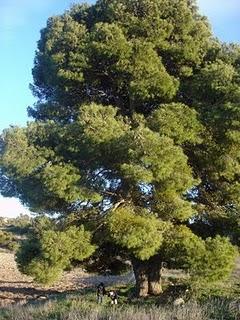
[{"left": 0, "top": 293, "right": 240, "bottom": 320}]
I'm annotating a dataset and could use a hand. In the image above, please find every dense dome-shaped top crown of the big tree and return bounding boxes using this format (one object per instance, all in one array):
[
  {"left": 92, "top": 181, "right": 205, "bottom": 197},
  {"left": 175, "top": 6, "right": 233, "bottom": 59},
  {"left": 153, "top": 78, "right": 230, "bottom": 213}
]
[{"left": 30, "top": 0, "right": 210, "bottom": 116}]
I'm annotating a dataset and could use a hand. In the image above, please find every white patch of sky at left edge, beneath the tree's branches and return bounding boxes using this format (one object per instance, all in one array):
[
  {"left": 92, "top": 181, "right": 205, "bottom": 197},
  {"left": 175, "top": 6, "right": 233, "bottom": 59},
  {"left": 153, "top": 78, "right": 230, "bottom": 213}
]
[{"left": 0, "top": 196, "right": 30, "bottom": 218}]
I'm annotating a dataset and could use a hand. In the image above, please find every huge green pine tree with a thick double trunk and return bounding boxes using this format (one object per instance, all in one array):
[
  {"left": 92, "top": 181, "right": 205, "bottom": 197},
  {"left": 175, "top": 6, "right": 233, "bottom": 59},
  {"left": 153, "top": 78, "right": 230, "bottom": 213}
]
[{"left": 1, "top": 0, "right": 240, "bottom": 295}]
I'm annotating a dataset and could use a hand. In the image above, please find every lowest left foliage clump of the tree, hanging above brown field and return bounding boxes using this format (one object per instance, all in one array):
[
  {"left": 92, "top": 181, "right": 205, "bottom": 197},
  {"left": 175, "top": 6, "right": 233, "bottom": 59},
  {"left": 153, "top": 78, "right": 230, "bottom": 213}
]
[{"left": 17, "top": 222, "right": 96, "bottom": 284}]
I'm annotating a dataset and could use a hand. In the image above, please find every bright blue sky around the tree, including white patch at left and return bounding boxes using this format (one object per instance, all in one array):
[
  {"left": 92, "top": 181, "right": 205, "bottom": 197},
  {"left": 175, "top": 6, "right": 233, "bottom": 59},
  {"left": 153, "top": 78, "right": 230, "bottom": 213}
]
[{"left": 0, "top": 0, "right": 240, "bottom": 216}]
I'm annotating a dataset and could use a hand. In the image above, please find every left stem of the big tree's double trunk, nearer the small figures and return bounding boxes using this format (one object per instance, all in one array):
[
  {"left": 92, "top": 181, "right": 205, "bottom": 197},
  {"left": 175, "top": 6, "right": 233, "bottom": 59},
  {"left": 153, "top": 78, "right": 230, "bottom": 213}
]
[{"left": 132, "top": 259, "right": 148, "bottom": 297}]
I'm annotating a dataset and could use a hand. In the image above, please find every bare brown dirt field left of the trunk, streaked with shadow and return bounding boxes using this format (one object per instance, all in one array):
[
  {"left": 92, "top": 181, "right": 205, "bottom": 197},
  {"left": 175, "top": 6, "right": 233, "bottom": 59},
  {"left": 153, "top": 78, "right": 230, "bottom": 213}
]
[{"left": 0, "top": 251, "right": 134, "bottom": 307}]
